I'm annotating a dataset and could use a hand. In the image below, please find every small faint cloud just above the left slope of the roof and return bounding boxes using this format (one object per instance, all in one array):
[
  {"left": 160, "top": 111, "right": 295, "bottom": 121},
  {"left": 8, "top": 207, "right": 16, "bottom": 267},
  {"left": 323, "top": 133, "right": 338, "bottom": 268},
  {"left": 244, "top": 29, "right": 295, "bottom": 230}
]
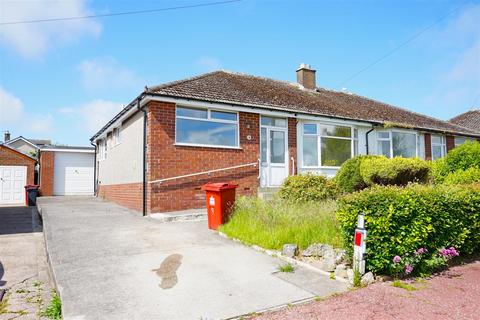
[{"left": 77, "top": 57, "right": 143, "bottom": 92}]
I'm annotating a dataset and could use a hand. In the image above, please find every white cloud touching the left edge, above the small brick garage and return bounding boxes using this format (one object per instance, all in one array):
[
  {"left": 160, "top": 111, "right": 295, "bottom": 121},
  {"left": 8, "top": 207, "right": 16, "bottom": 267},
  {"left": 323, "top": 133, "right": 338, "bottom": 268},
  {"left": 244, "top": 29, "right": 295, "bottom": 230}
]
[{"left": 0, "top": 87, "right": 53, "bottom": 135}]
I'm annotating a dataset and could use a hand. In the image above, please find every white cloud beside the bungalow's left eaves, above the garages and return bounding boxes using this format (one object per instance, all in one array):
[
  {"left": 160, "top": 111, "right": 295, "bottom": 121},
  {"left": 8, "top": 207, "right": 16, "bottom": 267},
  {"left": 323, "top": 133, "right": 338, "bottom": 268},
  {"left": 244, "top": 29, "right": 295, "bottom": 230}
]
[{"left": 58, "top": 100, "right": 123, "bottom": 134}]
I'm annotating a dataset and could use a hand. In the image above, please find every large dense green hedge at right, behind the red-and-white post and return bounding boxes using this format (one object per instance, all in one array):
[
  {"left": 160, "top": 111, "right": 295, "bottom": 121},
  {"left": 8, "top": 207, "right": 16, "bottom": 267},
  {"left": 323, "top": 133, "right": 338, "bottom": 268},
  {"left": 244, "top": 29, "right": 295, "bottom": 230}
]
[{"left": 337, "top": 184, "right": 480, "bottom": 273}]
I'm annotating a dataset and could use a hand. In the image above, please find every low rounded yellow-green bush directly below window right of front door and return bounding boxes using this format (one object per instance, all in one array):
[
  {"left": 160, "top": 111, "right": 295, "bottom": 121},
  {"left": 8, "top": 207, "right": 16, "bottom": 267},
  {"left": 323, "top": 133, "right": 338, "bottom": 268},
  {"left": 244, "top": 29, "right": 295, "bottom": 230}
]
[{"left": 279, "top": 174, "right": 338, "bottom": 202}]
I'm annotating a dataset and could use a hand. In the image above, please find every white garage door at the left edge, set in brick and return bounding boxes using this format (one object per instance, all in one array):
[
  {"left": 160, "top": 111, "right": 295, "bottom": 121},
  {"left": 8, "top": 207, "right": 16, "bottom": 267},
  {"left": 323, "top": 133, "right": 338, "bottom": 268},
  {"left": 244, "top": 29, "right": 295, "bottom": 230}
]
[{"left": 0, "top": 166, "right": 27, "bottom": 205}]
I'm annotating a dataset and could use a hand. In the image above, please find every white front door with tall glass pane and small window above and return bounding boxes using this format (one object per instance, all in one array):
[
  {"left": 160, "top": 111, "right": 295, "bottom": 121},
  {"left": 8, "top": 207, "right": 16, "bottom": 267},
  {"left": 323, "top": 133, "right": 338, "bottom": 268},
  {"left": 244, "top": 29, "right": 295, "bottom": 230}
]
[{"left": 260, "top": 116, "right": 288, "bottom": 187}]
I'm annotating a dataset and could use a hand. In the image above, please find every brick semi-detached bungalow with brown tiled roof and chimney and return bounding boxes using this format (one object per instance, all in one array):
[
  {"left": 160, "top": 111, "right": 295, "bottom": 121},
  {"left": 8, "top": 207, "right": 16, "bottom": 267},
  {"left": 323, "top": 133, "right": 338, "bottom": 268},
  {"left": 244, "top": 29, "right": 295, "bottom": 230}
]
[{"left": 91, "top": 64, "right": 480, "bottom": 214}]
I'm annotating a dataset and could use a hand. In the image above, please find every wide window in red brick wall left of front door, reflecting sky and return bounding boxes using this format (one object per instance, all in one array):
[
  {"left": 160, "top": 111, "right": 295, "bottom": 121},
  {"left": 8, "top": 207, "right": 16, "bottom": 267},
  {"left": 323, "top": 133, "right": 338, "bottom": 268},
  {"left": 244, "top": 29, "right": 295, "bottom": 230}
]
[{"left": 175, "top": 106, "right": 240, "bottom": 148}]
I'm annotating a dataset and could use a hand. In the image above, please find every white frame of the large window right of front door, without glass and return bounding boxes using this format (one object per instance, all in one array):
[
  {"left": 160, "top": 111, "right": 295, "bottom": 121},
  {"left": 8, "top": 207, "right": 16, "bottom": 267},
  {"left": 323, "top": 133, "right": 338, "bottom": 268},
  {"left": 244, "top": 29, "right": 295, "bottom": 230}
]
[{"left": 299, "top": 121, "right": 358, "bottom": 170}]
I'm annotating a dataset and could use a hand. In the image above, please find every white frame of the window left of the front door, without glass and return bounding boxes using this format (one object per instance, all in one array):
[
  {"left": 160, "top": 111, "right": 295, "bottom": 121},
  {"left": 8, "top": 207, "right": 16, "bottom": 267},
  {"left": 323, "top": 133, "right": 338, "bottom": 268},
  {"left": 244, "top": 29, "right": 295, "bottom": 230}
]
[{"left": 175, "top": 105, "right": 241, "bottom": 149}]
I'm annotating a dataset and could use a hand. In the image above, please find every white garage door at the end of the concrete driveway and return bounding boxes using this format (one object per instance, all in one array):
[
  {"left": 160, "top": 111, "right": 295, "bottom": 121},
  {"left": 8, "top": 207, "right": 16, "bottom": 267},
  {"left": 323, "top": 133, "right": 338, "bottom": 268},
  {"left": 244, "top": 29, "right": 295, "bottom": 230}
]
[{"left": 53, "top": 152, "right": 94, "bottom": 196}]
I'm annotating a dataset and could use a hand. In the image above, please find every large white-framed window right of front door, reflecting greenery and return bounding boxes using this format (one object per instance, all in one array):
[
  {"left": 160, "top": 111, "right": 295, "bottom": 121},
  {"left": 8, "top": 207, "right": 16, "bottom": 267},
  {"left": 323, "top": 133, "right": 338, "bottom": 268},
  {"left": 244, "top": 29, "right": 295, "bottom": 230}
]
[{"left": 302, "top": 123, "right": 355, "bottom": 168}]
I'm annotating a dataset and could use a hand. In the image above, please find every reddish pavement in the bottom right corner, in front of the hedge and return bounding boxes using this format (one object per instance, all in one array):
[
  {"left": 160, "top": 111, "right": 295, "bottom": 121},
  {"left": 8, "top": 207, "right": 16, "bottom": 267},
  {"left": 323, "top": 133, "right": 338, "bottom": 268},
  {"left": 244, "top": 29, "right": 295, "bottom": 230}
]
[{"left": 254, "top": 261, "right": 480, "bottom": 320}]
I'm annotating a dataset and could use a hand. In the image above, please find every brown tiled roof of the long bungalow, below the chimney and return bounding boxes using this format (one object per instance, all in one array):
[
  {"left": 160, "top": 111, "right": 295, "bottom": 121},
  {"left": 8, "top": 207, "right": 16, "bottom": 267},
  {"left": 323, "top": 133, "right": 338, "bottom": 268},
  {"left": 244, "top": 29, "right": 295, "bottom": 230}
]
[{"left": 146, "top": 71, "right": 480, "bottom": 136}]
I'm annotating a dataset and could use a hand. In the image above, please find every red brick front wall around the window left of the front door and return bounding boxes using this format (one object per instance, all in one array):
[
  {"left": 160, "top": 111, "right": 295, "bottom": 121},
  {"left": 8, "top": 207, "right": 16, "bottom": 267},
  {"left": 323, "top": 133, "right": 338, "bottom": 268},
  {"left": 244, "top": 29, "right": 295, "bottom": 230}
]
[{"left": 147, "top": 102, "right": 260, "bottom": 213}]
